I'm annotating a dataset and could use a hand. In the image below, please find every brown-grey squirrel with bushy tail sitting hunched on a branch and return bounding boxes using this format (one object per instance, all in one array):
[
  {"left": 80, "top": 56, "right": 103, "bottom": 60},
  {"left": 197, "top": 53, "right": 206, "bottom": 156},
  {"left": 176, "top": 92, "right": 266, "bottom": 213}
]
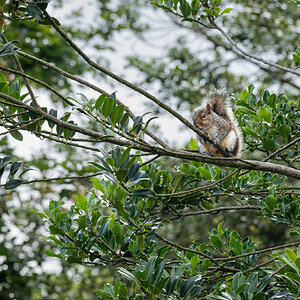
[{"left": 193, "top": 93, "right": 242, "bottom": 157}]
